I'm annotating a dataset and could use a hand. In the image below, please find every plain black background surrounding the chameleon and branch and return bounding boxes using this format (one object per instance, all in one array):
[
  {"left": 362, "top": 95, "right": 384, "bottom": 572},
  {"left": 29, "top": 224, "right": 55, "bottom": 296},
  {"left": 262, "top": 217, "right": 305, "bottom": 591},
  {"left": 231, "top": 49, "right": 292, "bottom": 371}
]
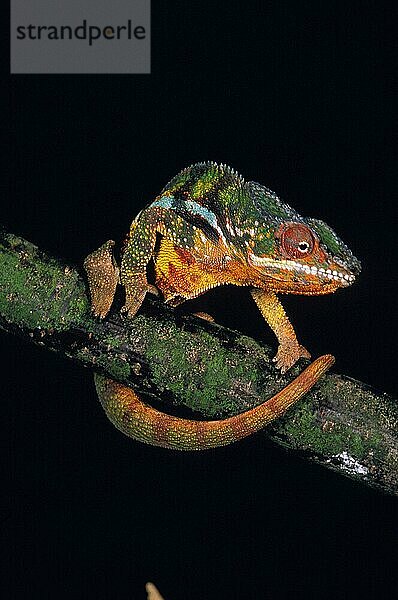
[{"left": 0, "top": 0, "right": 397, "bottom": 600}]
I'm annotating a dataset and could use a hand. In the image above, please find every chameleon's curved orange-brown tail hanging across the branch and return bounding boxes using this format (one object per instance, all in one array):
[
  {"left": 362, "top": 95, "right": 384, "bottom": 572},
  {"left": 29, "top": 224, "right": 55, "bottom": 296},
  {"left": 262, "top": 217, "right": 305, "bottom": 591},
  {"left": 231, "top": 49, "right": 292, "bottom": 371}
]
[{"left": 95, "top": 354, "right": 334, "bottom": 450}]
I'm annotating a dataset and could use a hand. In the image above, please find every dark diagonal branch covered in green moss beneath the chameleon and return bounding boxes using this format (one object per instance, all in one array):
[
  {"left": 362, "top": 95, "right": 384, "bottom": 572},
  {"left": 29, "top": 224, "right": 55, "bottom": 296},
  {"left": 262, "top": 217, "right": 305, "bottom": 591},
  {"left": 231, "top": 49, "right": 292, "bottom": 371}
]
[{"left": 0, "top": 233, "right": 398, "bottom": 495}]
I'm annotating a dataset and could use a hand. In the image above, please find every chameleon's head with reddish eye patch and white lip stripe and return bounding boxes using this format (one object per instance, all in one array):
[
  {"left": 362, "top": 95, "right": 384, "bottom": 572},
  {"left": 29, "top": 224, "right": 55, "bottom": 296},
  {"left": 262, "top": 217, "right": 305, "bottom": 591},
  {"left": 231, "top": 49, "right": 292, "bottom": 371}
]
[{"left": 248, "top": 217, "right": 361, "bottom": 295}]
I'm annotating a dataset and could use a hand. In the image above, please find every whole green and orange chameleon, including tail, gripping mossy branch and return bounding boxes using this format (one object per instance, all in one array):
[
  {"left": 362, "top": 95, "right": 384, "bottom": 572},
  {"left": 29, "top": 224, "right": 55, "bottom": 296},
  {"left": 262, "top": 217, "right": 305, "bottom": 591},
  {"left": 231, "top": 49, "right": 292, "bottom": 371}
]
[{"left": 84, "top": 162, "right": 361, "bottom": 450}]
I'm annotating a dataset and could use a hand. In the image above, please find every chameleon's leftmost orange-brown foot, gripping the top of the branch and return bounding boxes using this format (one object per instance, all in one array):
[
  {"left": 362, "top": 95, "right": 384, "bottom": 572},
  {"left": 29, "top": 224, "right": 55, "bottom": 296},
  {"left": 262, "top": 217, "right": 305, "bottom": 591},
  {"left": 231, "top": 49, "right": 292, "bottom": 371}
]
[{"left": 83, "top": 240, "right": 119, "bottom": 319}]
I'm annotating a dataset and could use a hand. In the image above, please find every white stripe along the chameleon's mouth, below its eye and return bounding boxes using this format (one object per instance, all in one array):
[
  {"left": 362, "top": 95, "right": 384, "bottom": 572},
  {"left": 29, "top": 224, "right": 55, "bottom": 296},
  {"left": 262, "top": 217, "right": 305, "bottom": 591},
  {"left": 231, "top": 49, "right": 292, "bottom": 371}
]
[{"left": 249, "top": 253, "right": 355, "bottom": 287}]
